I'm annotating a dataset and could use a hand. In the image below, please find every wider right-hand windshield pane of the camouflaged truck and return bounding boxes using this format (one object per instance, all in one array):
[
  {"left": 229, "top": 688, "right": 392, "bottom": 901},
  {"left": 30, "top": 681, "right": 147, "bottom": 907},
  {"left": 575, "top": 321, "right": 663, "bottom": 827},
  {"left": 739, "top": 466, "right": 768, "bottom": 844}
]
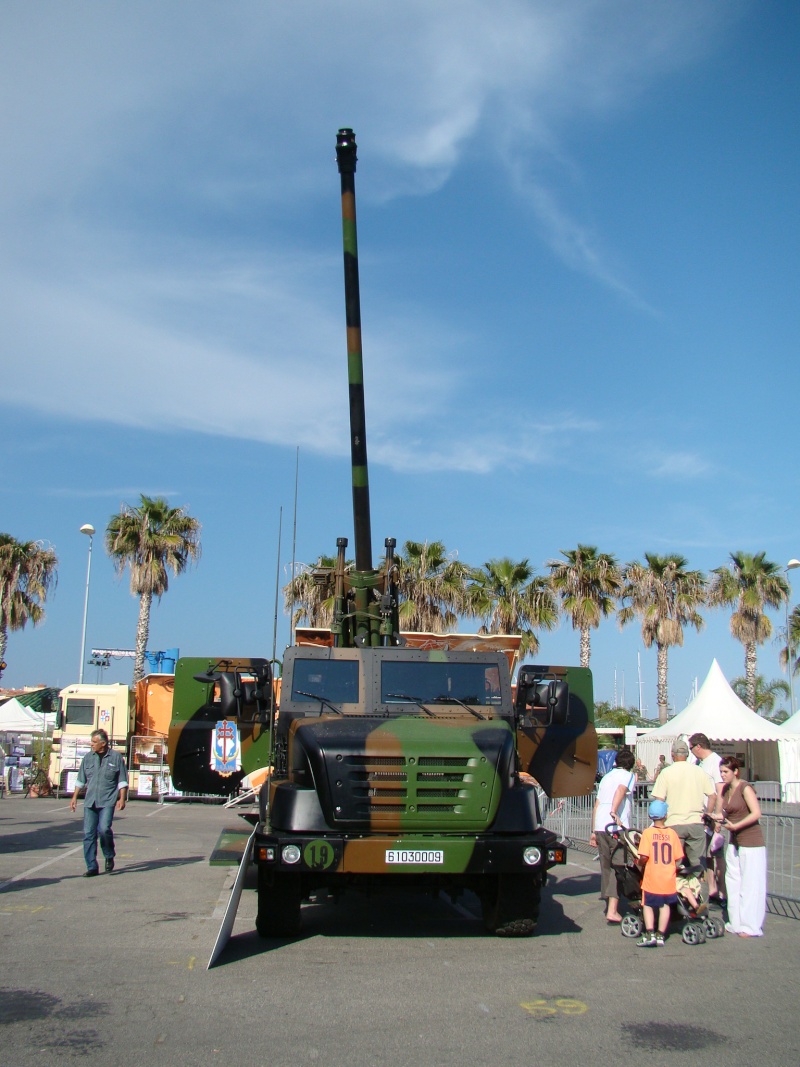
[{"left": 381, "top": 659, "right": 500, "bottom": 706}]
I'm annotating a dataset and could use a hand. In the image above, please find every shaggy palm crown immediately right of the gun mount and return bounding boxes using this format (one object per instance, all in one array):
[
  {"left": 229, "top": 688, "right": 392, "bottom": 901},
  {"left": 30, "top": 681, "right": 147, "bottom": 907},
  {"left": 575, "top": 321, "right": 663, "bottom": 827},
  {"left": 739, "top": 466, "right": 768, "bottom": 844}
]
[{"left": 395, "top": 541, "right": 470, "bottom": 634}]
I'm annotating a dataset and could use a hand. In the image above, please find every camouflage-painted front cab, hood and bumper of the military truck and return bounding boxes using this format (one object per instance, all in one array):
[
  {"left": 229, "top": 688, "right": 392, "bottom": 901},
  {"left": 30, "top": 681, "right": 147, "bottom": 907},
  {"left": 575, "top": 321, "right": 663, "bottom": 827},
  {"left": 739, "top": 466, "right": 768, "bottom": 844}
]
[{"left": 256, "top": 647, "right": 564, "bottom": 885}]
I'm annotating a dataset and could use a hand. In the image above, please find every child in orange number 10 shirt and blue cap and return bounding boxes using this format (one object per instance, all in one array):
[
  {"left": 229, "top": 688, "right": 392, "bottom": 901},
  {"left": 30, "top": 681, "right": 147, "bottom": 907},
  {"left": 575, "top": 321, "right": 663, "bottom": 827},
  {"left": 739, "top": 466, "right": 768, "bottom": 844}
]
[{"left": 636, "top": 800, "right": 684, "bottom": 949}]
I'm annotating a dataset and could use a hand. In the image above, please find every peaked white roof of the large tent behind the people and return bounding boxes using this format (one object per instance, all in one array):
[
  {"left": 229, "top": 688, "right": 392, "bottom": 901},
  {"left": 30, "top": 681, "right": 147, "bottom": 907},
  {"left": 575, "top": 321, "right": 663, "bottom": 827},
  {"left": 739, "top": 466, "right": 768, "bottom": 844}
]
[{"left": 647, "top": 659, "right": 798, "bottom": 740}]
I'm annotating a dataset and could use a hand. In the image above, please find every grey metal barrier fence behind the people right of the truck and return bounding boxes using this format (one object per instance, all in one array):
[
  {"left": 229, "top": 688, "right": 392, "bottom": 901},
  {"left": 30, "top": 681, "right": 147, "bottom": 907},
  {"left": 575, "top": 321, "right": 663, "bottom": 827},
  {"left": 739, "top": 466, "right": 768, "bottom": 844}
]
[{"left": 539, "top": 793, "right": 800, "bottom": 919}]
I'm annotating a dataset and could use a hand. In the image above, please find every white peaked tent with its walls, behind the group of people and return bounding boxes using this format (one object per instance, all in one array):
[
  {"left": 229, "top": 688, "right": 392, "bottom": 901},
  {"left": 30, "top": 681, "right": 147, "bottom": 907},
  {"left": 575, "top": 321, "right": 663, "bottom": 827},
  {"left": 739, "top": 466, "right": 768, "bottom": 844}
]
[{"left": 636, "top": 659, "right": 800, "bottom": 802}]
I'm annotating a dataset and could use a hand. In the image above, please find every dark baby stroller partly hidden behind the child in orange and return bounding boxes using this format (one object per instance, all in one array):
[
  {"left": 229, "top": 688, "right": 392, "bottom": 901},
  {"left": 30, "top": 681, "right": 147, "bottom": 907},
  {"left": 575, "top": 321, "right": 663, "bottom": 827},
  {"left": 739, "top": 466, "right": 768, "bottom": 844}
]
[{"left": 606, "top": 825, "right": 725, "bottom": 944}]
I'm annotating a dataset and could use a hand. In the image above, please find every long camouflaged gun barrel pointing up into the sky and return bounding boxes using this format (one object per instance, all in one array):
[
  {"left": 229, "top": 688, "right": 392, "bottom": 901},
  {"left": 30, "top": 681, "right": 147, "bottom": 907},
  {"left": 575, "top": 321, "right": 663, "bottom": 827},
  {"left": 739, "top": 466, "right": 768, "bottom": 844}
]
[{"left": 336, "top": 129, "right": 372, "bottom": 572}]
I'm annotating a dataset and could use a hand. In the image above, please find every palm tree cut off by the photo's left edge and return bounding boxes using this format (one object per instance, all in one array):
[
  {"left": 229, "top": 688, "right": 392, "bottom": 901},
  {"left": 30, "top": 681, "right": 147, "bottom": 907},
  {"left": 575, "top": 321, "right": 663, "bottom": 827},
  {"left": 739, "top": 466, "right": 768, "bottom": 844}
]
[{"left": 0, "top": 534, "right": 59, "bottom": 675}]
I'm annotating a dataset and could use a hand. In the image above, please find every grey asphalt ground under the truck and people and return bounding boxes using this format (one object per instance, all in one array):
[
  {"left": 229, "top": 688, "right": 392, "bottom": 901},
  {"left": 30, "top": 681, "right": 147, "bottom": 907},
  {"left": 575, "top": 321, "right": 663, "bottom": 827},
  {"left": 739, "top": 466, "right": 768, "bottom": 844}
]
[{"left": 0, "top": 797, "right": 800, "bottom": 1067}]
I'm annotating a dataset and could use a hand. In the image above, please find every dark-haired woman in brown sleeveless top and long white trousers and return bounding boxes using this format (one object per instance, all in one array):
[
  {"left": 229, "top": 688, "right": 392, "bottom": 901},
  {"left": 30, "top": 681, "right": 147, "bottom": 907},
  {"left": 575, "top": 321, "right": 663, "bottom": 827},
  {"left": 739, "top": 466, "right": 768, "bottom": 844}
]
[{"left": 719, "top": 755, "right": 767, "bottom": 937}]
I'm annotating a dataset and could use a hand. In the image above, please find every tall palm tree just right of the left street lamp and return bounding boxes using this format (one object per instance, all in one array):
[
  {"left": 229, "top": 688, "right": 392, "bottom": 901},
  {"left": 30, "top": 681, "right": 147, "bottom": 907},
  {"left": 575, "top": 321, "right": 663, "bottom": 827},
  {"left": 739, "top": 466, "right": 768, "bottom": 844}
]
[{"left": 106, "top": 493, "right": 201, "bottom": 683}]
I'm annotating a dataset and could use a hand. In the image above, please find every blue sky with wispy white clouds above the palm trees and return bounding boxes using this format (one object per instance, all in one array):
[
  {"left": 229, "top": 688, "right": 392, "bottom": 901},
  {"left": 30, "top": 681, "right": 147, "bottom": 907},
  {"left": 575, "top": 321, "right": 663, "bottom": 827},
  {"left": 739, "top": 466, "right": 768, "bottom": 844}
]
[{"left": 0, "top": 0, "right": 800, "bottom": 714}]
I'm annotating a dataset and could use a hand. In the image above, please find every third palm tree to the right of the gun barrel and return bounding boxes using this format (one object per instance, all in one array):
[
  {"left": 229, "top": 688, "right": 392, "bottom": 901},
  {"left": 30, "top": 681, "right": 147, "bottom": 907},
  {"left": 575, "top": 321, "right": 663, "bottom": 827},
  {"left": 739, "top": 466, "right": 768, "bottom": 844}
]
[{"left": 547, "top": 544, "right": 622, "bottom": 667}]
